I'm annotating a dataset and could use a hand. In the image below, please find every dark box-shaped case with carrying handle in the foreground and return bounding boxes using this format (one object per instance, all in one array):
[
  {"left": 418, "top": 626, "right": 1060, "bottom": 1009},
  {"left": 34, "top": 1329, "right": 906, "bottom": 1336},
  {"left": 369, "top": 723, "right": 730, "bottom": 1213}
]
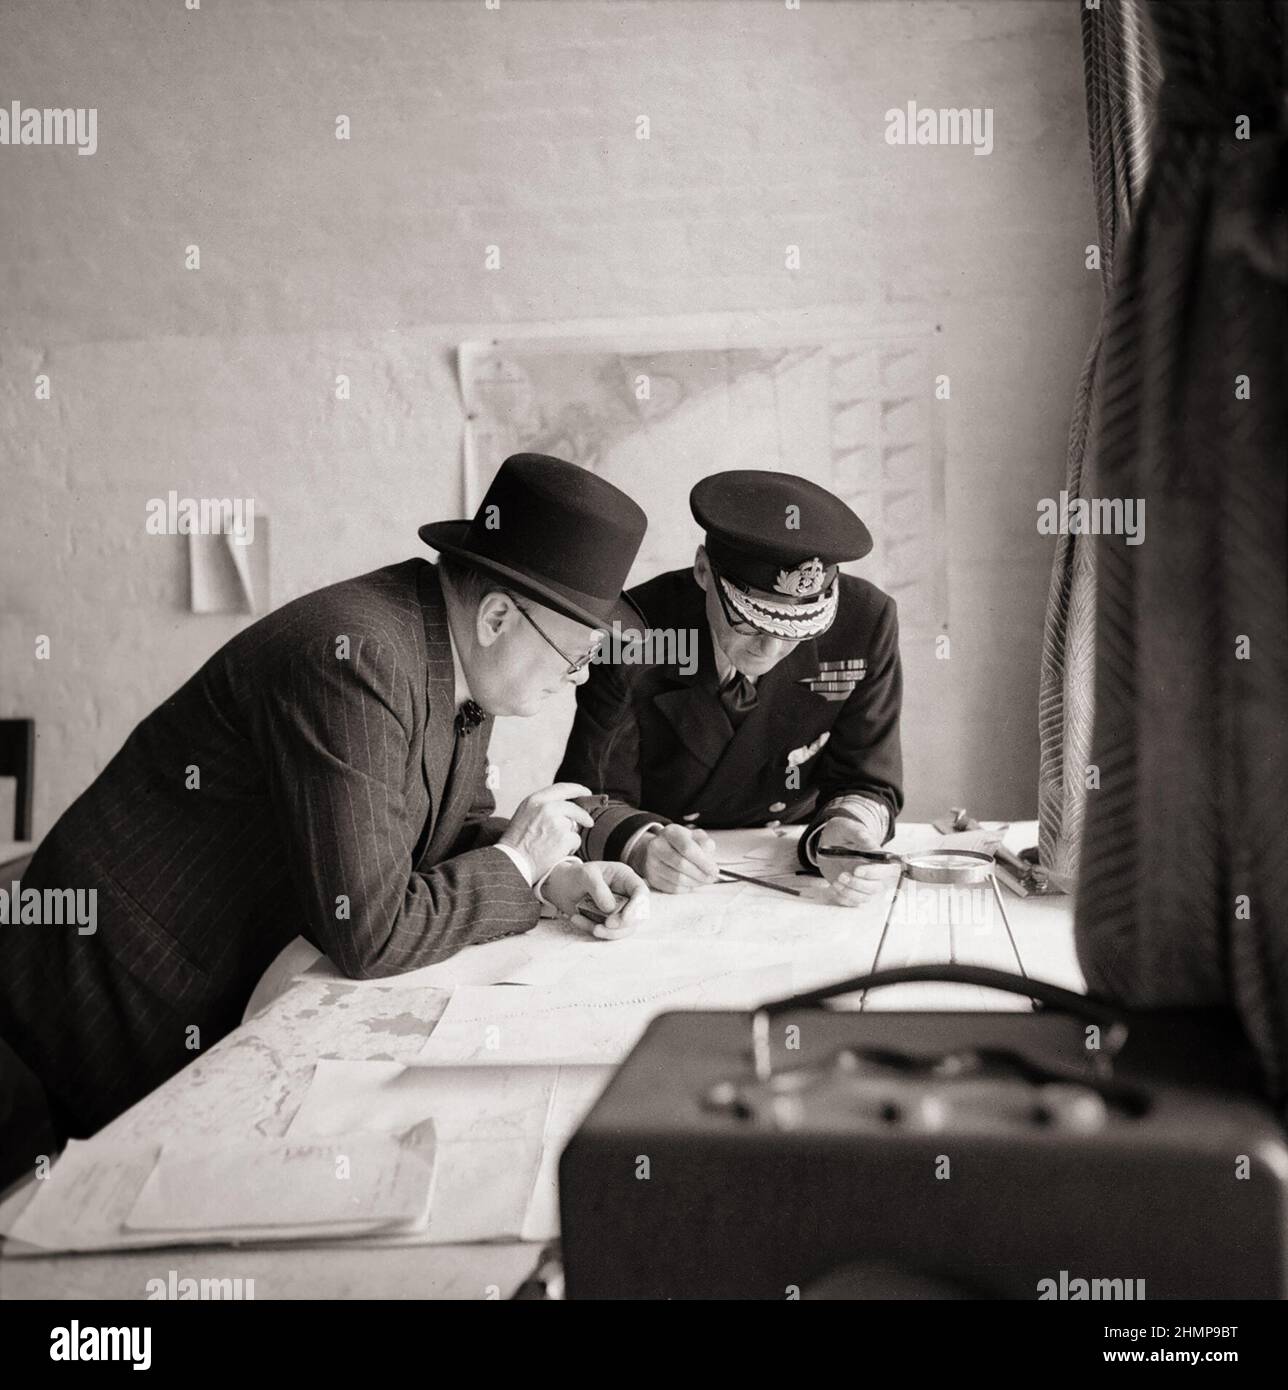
[{"left": 560, "top": 966, "right": 1288, "bottom": 1300}]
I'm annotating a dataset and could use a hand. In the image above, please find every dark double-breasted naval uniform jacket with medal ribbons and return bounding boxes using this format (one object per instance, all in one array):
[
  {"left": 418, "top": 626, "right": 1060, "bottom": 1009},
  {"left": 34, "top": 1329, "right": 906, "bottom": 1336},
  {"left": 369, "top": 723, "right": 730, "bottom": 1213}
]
[{"left": 557, "top": 570, "right": 903, "bottom": 859}]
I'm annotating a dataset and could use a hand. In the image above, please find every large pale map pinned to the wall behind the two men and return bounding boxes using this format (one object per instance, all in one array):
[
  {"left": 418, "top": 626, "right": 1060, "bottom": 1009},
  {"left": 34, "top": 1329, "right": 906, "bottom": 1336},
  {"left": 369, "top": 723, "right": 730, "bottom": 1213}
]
[{"left": 460, "top": 329, "right": 948, "bottom": 813}]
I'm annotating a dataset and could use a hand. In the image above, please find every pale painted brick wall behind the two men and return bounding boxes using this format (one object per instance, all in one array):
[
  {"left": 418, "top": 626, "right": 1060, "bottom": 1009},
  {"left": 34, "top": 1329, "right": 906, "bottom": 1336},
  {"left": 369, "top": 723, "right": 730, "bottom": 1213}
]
[{"left": 0, "top": 0, "right": 1098, "bottom": 838}]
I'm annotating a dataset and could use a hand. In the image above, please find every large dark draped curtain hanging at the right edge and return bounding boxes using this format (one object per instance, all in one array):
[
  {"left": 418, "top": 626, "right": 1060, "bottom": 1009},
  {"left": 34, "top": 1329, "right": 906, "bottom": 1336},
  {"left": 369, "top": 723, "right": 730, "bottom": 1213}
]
[{"left": 1077, "top": 0, "right": 1288, "bottom": 1102}]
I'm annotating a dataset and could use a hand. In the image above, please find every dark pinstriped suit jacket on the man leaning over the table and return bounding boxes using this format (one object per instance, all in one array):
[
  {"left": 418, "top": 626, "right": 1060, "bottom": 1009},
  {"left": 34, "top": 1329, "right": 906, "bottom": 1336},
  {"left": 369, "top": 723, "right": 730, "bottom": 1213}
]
[{"left": 0, "top": 560, "right": 540, "bottom": 1136}]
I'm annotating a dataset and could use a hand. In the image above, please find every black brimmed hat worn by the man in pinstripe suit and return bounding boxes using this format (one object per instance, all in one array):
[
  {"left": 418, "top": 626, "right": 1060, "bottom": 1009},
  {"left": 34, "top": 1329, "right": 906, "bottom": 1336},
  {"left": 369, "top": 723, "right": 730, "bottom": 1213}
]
[{"left": 418, "top": 453, "right": 647, "bottom": 627}]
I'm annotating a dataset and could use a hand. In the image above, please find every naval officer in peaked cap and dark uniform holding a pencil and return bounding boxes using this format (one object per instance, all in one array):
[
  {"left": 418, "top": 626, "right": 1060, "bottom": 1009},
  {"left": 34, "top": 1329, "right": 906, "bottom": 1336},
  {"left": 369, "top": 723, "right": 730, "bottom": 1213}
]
[{"left": 557, "top": 470, "right": 903, "bottom": 906}]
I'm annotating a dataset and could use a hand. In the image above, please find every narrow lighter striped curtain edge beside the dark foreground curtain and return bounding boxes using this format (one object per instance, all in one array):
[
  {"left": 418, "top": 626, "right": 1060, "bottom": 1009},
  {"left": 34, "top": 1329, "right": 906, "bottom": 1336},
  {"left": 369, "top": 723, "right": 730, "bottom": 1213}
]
[{"left": 1038, "top": 0, "right": 1160, "bottom": 877}]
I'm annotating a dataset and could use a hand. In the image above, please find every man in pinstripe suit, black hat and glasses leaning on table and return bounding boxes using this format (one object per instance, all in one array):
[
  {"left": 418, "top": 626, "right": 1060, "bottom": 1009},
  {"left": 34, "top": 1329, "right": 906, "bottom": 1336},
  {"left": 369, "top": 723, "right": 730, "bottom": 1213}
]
[{"left": 0, "top": 455, "right": 647, "bottom": 1137}]
